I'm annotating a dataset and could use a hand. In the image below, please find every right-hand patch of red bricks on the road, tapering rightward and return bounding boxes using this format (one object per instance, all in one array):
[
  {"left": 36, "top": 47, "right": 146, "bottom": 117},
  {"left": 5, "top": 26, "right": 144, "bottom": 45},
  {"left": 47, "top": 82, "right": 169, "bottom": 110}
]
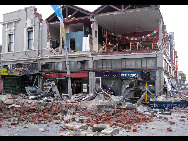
[{"left": 72, "top": 108, "right": 153, "bottom": 128}]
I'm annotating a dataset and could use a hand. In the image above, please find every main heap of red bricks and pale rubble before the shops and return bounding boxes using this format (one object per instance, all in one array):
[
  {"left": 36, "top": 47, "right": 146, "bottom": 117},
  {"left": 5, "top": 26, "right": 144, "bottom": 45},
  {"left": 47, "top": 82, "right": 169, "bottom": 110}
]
[{"left": 0, "top": 91, "right": 156, "bottom": 135}]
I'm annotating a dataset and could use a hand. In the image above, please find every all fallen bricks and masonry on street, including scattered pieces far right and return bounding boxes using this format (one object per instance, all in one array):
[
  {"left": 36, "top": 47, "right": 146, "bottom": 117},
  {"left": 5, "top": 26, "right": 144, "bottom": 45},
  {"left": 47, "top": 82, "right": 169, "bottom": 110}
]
[{"left": 0, "top": 92, "right": 188, "bottom": 136}]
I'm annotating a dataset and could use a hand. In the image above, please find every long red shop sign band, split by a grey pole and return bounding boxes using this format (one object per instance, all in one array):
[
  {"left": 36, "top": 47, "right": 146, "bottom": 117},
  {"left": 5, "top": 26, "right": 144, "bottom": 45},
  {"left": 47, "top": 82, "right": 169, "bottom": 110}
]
[{"left": 44, "top": 72, "right": 88, "bottom": 78}]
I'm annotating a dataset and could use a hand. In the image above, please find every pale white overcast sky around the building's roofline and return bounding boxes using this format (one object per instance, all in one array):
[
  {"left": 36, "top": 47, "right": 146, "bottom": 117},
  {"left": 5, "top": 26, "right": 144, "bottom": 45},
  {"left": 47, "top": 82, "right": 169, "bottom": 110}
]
[{"left": 0, "top": 5, "right": 188, "bottom": 77}]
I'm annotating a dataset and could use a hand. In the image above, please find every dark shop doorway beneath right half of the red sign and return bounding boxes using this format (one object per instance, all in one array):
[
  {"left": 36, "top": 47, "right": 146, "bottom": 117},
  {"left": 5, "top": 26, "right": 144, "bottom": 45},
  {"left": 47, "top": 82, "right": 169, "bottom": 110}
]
[{"left": 72, "top": 78, "right": 82, "bottom": 94}]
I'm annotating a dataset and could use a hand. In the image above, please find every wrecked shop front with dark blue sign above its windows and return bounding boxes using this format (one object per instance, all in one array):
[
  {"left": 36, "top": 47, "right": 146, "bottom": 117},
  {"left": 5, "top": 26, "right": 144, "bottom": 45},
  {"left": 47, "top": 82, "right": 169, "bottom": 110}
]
[{"left": 95, "top": 71, "right": 155, "bottom": 96}]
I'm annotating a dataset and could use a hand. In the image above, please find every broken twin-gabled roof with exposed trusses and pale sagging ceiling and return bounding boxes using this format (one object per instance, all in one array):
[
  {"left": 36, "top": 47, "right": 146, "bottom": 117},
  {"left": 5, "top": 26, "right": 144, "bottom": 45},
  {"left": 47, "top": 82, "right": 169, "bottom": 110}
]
[{"left": 47, "top": 5, "right": 162, "bottom": 34}]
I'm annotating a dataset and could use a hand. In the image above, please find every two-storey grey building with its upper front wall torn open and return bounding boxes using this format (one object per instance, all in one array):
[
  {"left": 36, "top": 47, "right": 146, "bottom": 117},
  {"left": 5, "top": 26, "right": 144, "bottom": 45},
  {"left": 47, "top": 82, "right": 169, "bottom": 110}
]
[{"left": 1, "top": 5, "right": 178, "bottom": 96}]
